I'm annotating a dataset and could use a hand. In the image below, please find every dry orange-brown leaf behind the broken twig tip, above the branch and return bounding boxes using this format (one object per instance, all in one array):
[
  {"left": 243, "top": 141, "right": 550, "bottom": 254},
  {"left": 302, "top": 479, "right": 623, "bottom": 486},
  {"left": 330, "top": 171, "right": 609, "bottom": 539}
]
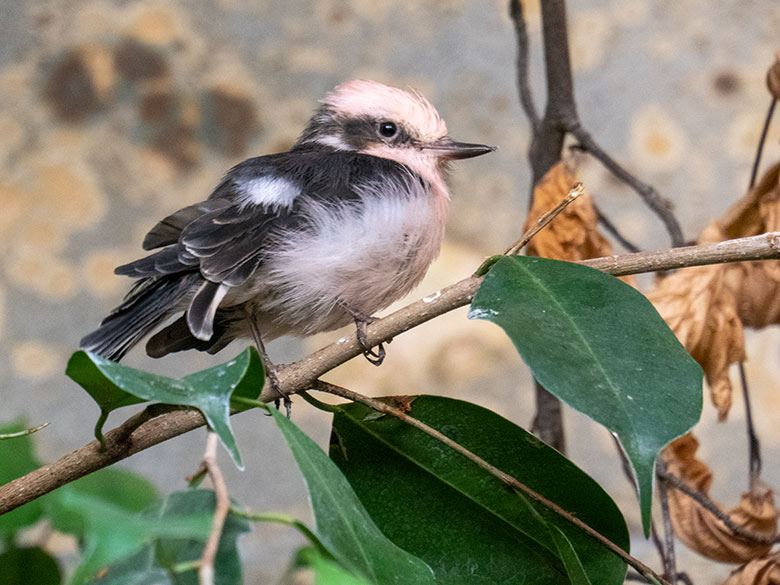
[{"left": 525, "top": 162, "right": 612, "bottom": 262}]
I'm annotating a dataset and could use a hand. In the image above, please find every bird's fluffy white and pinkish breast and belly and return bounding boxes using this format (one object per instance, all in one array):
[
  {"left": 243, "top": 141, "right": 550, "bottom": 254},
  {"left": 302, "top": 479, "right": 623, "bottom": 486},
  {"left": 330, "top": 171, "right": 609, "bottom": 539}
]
[{"left": 250, "top": 179, "right": 447, "bottom": 335}]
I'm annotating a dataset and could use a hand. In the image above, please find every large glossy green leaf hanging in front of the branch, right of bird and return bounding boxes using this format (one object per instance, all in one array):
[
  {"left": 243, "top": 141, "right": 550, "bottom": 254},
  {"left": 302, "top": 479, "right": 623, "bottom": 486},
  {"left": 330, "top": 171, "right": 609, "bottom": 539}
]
[{"left": 469, "top": 256, "right": 702, "bottom": 535}]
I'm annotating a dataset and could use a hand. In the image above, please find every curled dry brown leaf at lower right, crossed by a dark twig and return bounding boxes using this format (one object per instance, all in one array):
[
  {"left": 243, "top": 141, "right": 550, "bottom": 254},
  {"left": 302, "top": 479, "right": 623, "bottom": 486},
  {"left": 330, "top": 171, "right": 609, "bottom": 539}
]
[{"left": 662, "top": 433, "right": 780, "bottom": 560}]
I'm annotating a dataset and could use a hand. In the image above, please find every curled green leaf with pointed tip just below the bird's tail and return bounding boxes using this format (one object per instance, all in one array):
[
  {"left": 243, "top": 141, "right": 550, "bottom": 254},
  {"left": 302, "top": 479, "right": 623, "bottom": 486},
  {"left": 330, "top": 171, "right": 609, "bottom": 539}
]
[{"left": 65, "top": 347, "right": 263, "bottom": 469}]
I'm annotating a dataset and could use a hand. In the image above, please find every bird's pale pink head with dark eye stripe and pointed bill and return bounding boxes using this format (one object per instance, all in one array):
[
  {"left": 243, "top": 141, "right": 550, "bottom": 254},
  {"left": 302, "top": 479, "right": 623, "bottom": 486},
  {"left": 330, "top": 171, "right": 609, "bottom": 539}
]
[{"left": 298, "top": 81, "right": 495, "bottom": 175}]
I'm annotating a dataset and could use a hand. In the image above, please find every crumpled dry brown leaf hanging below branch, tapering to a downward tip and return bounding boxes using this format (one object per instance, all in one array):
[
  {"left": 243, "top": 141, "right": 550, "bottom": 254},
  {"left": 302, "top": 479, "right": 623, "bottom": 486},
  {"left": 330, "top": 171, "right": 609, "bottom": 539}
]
[{"left": 648, "top": 224, "right": 745, "bottom": 420}]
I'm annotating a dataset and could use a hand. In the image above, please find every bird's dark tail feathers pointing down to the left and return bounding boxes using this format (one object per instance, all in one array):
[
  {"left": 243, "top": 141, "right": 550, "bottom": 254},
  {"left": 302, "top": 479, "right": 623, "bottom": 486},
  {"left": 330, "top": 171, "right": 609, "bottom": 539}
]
[{"left": 79, "top": 274, "right": 199, "bottom": 361}]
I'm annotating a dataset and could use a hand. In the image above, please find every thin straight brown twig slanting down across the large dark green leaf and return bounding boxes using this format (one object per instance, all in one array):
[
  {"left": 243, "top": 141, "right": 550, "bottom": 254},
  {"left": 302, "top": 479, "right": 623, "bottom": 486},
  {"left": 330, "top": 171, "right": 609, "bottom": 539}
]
[{"left": 312, "top": 380, "right": 670, "bottom": 585}]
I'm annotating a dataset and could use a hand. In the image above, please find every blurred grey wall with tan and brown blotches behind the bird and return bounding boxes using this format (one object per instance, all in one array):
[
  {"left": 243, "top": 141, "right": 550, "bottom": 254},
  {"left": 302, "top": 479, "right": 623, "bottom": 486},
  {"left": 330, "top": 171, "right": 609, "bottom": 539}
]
[{"left": 0, "top": 0, "right": 780, "bottom": 583}]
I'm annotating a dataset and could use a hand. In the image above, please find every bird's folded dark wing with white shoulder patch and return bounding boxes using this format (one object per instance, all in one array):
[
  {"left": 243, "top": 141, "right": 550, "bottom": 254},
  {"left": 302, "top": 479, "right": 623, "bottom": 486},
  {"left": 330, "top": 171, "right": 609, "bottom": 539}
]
[{"left": 115, "top": 149, "right": 408, "bottom": 340}]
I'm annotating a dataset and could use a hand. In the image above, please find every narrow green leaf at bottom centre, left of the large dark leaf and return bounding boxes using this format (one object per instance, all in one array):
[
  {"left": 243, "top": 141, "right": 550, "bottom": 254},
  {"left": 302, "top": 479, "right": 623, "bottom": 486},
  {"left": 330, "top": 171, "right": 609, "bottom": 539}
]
[{"left": 270, "top": 408, "right": 434, "bottom": 585}]
